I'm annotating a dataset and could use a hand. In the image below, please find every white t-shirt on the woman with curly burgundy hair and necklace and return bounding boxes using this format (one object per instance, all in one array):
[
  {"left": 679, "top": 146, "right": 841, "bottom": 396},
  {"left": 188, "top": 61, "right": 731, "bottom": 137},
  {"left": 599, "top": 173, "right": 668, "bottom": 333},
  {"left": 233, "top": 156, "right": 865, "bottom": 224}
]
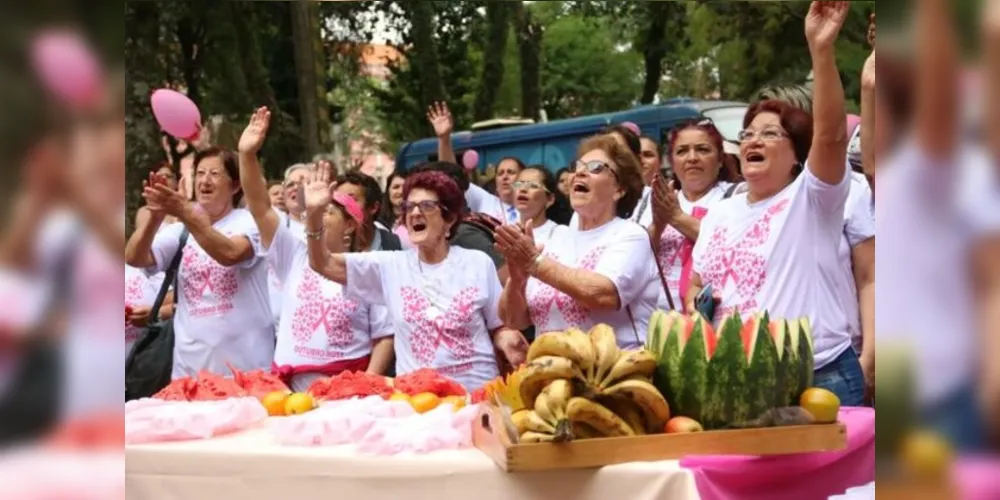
[{"left": 345, "top": 246, "right": 503, "bottom": 391}]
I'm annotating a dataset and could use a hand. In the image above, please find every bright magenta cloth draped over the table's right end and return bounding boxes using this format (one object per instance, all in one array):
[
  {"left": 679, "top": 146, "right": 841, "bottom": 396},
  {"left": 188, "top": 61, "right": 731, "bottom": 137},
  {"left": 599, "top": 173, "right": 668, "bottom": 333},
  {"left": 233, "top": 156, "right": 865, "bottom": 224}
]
[{"left": 681, "top": 408, "right": 875, "bottom": 500}]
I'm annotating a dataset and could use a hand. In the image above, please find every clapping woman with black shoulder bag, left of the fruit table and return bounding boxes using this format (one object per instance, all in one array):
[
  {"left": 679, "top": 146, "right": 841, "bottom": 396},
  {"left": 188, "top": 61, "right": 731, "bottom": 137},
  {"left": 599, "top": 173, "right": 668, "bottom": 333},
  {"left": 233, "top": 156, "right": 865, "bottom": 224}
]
[{"left": 125, "top": 148, "right": 274, "bottom": 378}]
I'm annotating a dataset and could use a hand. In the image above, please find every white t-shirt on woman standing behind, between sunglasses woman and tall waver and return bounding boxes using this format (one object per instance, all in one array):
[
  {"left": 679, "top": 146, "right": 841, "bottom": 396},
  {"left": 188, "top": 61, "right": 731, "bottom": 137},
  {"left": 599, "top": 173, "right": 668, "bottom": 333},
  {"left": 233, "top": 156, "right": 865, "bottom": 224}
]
[{"left": 632, "top": 182, "right": 732, "bottom": 309}]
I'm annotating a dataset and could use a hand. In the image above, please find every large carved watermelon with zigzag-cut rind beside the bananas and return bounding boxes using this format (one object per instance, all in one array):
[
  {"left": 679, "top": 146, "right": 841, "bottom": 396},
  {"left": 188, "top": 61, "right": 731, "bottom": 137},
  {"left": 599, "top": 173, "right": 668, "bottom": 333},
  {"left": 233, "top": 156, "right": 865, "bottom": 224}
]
[{"left": 646, "top": 311, "right": 813, "bottom": 429}]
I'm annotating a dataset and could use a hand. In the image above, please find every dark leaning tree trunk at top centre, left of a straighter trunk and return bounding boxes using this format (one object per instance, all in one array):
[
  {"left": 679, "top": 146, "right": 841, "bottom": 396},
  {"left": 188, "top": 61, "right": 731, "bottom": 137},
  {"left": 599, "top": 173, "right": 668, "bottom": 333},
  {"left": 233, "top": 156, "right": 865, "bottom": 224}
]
[{"left": 472, "top": 2, "right": 511, "bottom": 121}]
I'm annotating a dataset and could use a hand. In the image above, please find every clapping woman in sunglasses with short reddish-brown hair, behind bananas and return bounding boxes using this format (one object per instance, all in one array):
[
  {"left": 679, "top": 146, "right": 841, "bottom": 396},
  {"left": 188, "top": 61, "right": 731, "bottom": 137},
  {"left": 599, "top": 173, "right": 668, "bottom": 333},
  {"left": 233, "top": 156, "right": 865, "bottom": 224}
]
[{"left": 496, "top": 135, "right": 662, "bottom": 348}]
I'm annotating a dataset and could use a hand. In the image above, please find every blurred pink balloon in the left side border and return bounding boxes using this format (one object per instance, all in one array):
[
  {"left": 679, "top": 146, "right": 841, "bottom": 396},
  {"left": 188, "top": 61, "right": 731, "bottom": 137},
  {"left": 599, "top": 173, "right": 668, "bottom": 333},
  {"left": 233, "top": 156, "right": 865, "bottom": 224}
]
[{"left": 31, "top": 31, "right": 103, "bottom": 106}]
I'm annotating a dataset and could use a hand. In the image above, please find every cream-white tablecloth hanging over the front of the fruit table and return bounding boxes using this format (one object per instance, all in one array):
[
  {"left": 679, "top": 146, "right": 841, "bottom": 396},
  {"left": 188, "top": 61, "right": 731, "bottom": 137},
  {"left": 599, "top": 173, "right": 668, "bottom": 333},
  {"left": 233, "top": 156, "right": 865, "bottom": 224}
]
[{"left": 125, "top": 429, "right": 698, "bottom": 500}]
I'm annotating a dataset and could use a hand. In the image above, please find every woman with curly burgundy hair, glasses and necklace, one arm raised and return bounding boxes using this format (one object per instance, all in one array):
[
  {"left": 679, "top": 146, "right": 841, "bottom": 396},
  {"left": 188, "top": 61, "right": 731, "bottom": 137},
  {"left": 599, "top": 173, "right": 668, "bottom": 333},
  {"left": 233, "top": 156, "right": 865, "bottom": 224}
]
[{"left": 306, "top": 172, "right": 527, "bottom": 391}]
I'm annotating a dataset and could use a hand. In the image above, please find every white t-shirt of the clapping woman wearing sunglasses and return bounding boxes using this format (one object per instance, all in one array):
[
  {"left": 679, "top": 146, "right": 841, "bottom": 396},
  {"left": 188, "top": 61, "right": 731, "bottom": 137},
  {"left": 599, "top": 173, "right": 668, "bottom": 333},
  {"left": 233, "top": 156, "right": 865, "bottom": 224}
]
[{"left": 526, "top": 218, "right": 663, "bottom": 349}]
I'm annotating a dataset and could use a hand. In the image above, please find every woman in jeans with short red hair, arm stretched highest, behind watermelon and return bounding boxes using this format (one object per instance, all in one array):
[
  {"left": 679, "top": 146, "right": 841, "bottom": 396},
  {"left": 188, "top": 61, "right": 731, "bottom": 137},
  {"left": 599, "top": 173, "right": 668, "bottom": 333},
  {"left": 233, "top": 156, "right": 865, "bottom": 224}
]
[{"left": 686, "top": 2, "right": 865, "bottom": 406}]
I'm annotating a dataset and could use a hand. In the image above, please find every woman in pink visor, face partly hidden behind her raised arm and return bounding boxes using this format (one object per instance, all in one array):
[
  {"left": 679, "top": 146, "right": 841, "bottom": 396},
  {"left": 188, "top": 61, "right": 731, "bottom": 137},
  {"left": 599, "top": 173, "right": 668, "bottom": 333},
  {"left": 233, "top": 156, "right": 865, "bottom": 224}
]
[{"left": 239, "top": 108, "right": 393, "bottom": 391}]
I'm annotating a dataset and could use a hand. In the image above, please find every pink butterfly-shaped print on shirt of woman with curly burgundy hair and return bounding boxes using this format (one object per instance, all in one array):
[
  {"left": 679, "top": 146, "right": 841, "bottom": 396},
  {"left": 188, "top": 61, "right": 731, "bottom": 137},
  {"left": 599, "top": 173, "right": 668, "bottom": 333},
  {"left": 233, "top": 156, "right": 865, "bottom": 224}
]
[{"left": 400, "top": 287, "right": 479, "bottom": 367}]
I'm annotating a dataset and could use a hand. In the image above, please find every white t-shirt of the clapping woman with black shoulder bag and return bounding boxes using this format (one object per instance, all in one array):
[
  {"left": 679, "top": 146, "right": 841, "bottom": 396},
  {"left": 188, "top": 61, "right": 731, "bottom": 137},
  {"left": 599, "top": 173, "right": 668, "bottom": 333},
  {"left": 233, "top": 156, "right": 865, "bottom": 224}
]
[{"left": 147, "top": 209, "right": 274, "bottom": 379}]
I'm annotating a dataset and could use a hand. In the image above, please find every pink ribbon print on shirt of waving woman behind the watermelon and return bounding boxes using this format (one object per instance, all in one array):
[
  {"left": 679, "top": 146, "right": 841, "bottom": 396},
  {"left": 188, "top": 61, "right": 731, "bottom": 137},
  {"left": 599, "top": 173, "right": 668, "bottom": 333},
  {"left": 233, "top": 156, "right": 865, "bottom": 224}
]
[{"left": 702, "top": 199, "right": 791, "bottom": 317}]
